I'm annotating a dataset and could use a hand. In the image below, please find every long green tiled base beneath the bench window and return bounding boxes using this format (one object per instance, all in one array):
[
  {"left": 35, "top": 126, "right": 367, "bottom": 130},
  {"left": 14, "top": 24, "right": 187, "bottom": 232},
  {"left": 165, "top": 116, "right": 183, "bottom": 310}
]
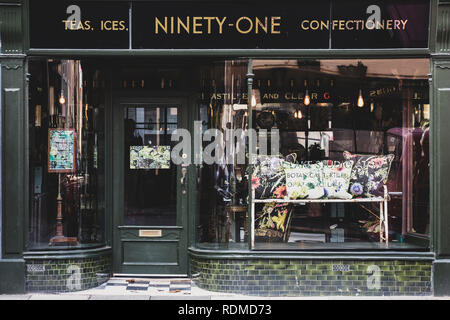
[{"left": 191, "top": 257, "right": 432, "bottom": 296}]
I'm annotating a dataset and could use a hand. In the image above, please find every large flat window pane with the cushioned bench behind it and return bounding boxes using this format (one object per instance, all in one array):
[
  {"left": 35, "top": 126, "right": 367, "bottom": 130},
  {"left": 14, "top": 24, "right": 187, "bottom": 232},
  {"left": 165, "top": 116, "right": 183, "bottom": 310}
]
[{"left": 250, "top": 59, "right": 430, "bottom": 250}]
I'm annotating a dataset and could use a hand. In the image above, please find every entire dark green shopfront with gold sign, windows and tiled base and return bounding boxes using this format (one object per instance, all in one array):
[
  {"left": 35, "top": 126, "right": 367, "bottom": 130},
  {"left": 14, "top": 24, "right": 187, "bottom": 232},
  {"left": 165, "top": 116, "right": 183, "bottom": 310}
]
[{"left": 0, "top": 0, "right": 450, "bottom": 296}]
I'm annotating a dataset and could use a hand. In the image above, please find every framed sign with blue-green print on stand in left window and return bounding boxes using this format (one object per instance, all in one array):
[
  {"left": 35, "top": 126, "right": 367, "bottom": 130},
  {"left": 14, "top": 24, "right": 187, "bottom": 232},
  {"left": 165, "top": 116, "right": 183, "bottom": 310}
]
[{"left": 48, "top": 129, "right": 75, "bottom": 173}]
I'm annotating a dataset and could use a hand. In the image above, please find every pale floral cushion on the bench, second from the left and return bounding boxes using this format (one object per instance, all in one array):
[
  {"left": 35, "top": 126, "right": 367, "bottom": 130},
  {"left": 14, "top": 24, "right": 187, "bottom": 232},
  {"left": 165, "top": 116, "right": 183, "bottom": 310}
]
[{"left": 284, "top": 162, "right": 325, "bottom": 199}]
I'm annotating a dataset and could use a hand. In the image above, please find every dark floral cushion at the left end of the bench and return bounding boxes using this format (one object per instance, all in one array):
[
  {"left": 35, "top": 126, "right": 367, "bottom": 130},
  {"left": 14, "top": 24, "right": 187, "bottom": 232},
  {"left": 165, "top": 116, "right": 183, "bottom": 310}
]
[{"left": 252, "top": 155, "right": 295, "bottom": 199}]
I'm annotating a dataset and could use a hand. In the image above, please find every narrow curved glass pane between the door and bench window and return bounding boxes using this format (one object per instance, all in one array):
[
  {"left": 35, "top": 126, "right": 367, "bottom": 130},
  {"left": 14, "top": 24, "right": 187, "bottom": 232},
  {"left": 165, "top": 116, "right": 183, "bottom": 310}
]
[{"left": 194, "top": 60, "right": 248, "bottom": 249}]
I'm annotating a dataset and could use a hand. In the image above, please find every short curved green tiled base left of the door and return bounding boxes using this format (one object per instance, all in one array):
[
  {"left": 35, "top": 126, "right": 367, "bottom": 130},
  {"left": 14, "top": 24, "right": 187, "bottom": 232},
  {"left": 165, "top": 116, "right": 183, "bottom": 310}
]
[{"left": 25, "top": 255, "right": 111, "bottom": 292}]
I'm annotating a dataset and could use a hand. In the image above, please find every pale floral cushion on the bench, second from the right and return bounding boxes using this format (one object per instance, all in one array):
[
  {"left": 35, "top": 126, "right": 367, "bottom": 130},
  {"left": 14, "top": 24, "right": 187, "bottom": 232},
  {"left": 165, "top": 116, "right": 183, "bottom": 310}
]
[{"left": 323, "top": 160, "right": 353, "bottom": 199}]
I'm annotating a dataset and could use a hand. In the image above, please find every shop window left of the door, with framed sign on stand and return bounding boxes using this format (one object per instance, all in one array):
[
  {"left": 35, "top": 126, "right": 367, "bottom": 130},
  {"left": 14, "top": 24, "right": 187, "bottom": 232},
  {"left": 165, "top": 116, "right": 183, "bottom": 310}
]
[{"left": 28, "top": 59, "right": 105, "bottom": 249}]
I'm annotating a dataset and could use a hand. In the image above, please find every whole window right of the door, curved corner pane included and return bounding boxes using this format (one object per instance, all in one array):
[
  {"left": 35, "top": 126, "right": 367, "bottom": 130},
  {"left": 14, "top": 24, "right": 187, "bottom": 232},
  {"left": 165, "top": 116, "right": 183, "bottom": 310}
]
[{"left": 197, "top": 59, "right": 430, "bottom": 250}]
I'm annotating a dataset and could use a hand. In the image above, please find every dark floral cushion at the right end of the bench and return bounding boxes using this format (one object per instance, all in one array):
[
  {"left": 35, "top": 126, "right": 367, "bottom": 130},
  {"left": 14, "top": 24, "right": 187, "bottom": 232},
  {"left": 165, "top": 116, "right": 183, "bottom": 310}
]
[{"left": 343, "top": 151, "right": 394, "bottom": 197}]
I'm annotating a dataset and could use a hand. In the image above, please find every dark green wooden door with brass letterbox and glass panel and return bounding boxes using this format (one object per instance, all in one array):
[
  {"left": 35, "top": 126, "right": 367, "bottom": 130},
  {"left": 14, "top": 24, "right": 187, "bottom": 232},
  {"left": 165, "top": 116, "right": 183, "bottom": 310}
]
[{"left": 112, "top": 98, "right": 188, "bottom": 275}]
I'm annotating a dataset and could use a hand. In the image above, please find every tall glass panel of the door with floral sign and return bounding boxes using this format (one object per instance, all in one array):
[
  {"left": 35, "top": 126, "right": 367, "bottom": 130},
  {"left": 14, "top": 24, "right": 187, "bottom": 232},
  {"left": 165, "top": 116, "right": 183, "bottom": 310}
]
[{"left": 124, "top": 105, "right": 178, "bottom": 226}]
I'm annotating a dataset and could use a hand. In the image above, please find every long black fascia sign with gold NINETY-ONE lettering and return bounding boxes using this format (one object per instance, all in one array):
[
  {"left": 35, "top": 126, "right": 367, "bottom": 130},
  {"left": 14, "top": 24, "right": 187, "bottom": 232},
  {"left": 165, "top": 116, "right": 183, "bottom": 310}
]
[{"left": 30, "top": 0, "right": 430, "bottom": 50}]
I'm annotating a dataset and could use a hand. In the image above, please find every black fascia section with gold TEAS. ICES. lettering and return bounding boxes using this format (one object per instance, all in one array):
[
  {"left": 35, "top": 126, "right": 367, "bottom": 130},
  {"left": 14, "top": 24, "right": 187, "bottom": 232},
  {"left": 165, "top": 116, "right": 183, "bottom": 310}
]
[{"left": 30, "top": 0, "right": 129, "bottom": 49}]
